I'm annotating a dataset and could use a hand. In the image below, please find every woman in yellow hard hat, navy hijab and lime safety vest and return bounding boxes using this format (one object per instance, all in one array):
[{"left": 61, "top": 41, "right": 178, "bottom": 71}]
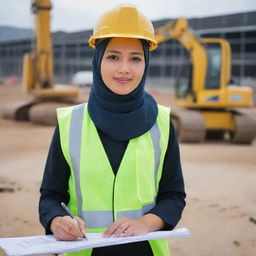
[{"left": 39, "top": 5, "right": 185, "bottom": 256}]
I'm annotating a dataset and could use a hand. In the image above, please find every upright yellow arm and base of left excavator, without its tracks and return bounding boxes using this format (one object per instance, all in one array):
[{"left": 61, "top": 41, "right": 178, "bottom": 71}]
[{"left": 22, "top": 0, "right": 78, "bottom": 101}]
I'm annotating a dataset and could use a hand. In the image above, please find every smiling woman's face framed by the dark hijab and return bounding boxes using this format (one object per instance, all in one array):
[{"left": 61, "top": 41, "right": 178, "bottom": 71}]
[{"left": 101, "top": 37, "right": 145, "bottom": 95}]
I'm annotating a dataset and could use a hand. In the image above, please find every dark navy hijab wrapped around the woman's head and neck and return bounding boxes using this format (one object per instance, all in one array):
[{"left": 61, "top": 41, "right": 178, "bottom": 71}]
[{"left": 88, "top": 39, "right": 158, "bottom": 141}]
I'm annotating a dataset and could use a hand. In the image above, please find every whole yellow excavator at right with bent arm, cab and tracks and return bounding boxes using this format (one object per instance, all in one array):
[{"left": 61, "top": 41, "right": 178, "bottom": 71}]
[{"left": 156, "top": 18, "right": 256, "bottom": 144}]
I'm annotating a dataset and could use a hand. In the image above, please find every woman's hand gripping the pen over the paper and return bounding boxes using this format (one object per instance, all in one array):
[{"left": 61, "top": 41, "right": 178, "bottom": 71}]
[{"left": 50, "top": 216, "right": 86, "bottom": 241}]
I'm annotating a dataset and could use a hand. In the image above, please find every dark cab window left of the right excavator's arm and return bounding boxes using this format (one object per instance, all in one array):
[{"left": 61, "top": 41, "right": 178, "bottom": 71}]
[{"left": 175, "top": 63, "right": 192, "bottom": 98}]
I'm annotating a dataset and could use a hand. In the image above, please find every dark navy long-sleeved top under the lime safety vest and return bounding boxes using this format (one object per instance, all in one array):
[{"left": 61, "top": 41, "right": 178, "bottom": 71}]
[{"left": 39, "top": 119, "right": 186, "bottom": 256}]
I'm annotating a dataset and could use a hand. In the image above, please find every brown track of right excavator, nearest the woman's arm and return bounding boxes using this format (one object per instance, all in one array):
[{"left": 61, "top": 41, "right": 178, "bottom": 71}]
[{"left": 171, "top": 108, "right": 206, "bottom": 143}]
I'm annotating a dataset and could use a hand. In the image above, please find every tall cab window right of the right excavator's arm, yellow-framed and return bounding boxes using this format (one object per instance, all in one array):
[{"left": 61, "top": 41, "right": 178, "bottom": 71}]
[{"left": 205, "top": 43, "right": 221, "bottom": 89}]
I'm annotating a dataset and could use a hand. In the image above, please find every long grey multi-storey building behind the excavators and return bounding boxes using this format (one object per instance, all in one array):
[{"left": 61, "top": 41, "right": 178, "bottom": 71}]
[{"left": 0, "top": 12, "right": 256, "bottom": 87}]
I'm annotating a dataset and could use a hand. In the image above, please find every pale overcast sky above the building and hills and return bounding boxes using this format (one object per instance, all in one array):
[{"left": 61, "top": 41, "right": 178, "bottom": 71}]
[{"left": 0, "top": 0, "right": 256, "bottom": 32}]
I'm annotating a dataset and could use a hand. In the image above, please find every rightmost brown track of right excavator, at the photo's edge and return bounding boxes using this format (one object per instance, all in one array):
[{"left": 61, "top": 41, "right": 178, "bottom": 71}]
[{"left": 230, "top": 112, "right": 256, "bottom": 144}]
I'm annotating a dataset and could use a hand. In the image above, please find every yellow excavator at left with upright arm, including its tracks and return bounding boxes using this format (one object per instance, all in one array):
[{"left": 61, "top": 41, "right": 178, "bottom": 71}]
[{"left": 4, "top": 0, "right": 78, "bottom": 124}]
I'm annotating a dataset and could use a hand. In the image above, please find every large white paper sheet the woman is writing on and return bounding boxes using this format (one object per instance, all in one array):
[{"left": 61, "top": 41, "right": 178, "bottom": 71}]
[{"left": 0, "top": 228, "right": 190, "bottom": 256}]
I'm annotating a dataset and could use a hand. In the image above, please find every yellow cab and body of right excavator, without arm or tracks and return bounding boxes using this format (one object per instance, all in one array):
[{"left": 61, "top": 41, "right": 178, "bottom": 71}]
[{"left": 176, "top": 38, "right": 253, "bottom": 109}]
